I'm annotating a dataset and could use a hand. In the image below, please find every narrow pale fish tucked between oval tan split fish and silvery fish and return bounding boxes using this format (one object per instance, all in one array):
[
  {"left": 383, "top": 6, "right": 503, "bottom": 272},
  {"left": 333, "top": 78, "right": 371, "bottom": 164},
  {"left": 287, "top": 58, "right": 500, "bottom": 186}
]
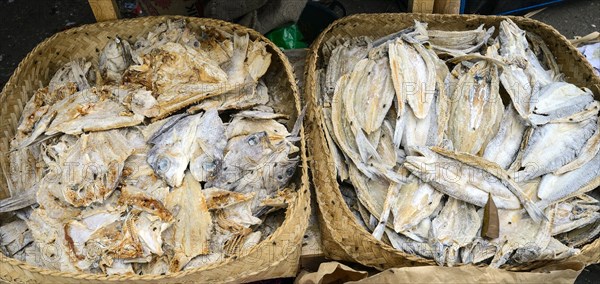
[{"left": 483, "top": 104, "right": 526, "bottom": 169}]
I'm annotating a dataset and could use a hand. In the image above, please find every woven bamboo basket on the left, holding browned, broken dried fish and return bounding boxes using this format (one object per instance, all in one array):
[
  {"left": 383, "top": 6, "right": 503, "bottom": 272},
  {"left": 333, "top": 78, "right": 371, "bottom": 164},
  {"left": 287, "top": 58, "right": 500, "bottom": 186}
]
[{"left": 0, "top": 16, "right": 310, "bottom": 283}]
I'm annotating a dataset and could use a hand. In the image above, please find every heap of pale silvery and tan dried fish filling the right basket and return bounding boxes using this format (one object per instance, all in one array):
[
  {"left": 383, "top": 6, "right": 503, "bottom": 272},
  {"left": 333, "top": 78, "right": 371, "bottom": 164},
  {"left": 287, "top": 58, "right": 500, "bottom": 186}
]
[{"left": 317, "top": 20, "right": 600, "bottom": 267}]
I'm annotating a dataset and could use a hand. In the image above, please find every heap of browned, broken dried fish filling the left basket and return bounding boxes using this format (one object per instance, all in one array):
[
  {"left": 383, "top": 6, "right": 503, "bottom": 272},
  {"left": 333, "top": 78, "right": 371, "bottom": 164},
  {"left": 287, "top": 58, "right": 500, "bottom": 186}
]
[{"left": 0, "top": 20, "right": 302, "bottom": 275}]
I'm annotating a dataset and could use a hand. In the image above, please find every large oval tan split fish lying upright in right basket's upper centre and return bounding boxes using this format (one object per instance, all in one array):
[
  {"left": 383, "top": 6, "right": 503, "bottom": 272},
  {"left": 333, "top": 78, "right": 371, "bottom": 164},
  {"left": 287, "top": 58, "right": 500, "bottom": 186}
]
[{"left": 448, "top": 61, "right": 504, "bottom": 154}]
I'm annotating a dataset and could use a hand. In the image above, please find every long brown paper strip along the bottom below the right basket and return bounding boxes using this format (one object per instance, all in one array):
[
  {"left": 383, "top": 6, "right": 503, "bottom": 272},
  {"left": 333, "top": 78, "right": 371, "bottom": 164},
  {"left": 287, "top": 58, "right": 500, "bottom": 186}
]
[{"left": 352, "top": 262, "right": 585, "bottom": 283}]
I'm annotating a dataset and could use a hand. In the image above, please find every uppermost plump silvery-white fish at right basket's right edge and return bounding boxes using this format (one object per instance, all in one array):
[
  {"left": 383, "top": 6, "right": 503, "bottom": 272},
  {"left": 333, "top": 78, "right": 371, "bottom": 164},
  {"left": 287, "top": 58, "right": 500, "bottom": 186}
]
[{"left": 529, "top": 82, "right": 594, "bottom": 125}]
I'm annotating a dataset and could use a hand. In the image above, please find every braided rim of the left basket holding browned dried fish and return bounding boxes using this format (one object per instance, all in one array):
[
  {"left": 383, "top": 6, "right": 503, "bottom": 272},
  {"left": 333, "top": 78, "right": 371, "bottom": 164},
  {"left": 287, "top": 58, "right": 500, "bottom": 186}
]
[{"left": 0, "top": 15, "right": 310, "bottom": 281}]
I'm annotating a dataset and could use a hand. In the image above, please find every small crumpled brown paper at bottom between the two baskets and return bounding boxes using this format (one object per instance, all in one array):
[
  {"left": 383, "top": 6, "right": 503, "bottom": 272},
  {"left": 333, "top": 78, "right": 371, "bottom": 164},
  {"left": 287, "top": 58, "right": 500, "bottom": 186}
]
[{"left": 294, "top": 261, "right": 369, "bottom": 284}]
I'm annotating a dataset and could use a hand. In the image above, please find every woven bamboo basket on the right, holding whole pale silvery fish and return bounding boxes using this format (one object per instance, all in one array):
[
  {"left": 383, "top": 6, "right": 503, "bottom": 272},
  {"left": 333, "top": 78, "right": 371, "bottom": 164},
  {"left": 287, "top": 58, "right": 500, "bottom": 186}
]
[{"left": 305, "top": 14, "right": 600, "bottom": 271}]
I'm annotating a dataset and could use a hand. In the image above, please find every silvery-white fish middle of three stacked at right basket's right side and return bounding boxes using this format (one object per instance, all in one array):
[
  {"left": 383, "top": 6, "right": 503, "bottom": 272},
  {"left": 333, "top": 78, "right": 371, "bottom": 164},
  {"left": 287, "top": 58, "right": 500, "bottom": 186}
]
[{"left": 515, "top": 118, "right": 597, "bottom": 181}]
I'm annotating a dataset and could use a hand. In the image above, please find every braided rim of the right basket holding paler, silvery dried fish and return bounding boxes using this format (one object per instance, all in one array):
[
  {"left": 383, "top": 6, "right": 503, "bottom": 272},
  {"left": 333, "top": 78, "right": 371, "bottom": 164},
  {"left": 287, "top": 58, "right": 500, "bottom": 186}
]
[{"left": 304, "top": 13, "right": 600, "bottom": 270}]
